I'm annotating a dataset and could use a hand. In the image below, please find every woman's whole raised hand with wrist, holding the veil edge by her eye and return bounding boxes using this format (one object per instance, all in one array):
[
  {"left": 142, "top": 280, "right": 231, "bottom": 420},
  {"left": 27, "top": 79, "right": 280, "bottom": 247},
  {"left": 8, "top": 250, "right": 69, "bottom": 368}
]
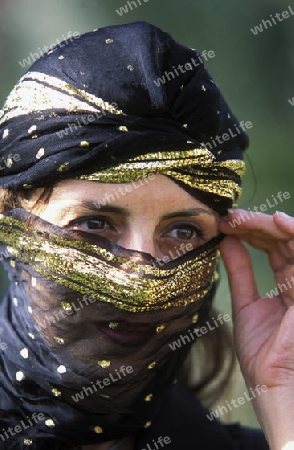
[{"left": 219, "top": 209, "right": 294, "bottom": 450}]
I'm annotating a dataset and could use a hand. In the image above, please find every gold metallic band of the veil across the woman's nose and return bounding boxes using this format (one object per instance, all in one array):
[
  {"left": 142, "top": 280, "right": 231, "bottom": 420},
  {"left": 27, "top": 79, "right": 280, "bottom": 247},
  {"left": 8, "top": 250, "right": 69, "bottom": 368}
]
[{"left": 0, "top": 209, "right": 222, "bottom": 312}]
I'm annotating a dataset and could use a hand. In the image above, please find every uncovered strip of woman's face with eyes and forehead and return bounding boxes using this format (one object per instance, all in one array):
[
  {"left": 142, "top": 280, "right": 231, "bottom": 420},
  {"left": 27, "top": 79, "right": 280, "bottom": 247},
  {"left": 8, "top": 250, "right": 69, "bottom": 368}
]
[{"left": 39, "top": 175, "right": 218, "bottom": 262}]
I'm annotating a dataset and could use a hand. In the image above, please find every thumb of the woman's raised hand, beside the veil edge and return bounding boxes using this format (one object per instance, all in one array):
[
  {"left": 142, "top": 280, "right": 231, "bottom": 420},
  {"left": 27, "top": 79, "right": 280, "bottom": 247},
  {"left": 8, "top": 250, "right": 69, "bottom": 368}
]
[{"left": 220, "top": 236, "right": 259, "bottom": 315}]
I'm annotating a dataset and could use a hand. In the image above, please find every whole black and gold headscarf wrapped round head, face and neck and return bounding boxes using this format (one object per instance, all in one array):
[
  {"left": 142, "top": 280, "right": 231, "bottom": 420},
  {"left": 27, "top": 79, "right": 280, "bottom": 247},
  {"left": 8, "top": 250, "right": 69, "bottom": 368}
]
[{"left": 0, "top": 22, "right": 247, "bottom": 448}]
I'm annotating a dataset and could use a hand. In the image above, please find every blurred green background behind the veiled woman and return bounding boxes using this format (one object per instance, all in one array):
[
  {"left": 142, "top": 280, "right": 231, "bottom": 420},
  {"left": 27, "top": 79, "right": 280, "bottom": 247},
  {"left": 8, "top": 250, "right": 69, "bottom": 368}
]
[{"left": 0, "top": 0, "right": 294, "bottom": 424}]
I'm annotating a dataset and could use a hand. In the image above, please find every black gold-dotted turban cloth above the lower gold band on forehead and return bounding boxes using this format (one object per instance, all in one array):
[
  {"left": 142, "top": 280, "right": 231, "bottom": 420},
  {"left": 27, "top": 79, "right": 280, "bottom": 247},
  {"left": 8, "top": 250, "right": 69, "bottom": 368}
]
[{"left": 0, "top": 22, "right": 248, "bottom": 207}]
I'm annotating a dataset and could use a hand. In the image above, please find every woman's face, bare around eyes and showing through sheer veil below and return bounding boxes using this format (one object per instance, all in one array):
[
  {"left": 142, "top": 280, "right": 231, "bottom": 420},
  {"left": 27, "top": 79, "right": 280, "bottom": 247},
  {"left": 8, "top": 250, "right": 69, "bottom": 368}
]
[{"left": 26, "top": 175, "right": 219, "bottom": 376}]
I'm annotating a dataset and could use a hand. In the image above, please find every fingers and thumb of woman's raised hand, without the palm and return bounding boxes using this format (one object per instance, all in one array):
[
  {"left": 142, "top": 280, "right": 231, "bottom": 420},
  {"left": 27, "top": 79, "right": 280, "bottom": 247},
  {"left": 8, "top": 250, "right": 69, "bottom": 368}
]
[{"left": 219, "top": 210, "right": 294, "bottom": 308}]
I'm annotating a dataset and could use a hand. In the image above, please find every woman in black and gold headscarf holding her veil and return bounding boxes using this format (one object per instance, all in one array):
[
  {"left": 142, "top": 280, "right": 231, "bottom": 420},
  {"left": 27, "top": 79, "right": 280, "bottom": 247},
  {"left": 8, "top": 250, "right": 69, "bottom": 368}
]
[{"left": 0, "top": 22, "right": 293, "bottom": 450}]
